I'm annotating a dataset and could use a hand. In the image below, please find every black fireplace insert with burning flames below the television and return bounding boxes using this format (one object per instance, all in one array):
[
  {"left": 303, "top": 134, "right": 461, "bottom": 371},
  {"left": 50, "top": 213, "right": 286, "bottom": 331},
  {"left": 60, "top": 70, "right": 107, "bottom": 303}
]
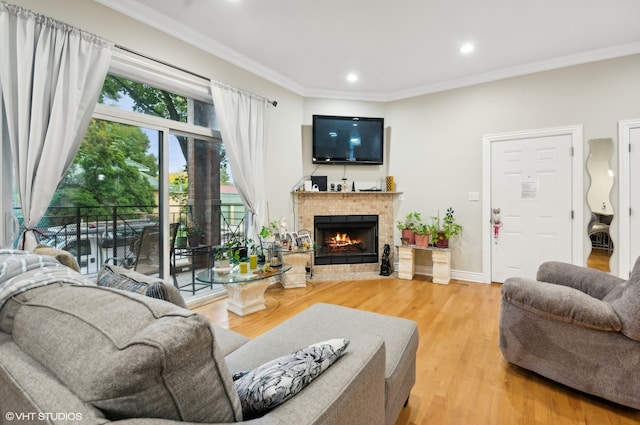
[{"left": 313, "top": 215, "right": 378, "bottom": 265}]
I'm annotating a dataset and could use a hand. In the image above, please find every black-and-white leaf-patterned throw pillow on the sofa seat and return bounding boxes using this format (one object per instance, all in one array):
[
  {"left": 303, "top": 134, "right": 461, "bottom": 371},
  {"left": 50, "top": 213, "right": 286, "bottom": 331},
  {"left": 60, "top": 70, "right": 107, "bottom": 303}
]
[{"left": 233, "top": 338, "right": 349, "bottom": 420}]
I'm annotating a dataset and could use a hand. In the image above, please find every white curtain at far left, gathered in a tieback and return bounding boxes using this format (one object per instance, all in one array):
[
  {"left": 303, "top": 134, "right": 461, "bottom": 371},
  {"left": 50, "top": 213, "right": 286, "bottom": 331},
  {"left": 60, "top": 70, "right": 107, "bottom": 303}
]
[{"left": 0, "top": 2, "right": 112, "bottom": 250}]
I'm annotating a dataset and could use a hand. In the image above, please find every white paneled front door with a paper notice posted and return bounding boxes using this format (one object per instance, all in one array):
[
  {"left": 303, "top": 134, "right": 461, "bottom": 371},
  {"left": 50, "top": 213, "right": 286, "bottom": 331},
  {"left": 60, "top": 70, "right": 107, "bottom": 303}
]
[{"left": 485, "top": 129, "right": 582, "bottom": 282}]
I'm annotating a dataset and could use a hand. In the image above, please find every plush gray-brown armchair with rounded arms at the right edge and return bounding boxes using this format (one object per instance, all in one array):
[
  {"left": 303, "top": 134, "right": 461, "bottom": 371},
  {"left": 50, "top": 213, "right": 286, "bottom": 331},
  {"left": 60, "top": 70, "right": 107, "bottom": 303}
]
[{"left": 499, "top": 259, "right": 640, "bottom": 409}]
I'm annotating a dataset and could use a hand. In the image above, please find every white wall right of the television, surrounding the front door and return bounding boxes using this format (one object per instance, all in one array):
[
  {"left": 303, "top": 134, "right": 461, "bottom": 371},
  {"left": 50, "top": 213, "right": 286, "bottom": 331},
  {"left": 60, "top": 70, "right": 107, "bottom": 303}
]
[{"left": 385, "top": 55, "right": 640, "bottom": 273}]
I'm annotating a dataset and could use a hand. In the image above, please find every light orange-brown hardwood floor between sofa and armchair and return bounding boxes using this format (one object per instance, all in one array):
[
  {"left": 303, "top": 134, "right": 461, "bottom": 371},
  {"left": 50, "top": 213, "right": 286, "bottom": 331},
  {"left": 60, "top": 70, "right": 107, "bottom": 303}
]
[{"left": 195, "top": 277, "right": 640, "bottom": 425}]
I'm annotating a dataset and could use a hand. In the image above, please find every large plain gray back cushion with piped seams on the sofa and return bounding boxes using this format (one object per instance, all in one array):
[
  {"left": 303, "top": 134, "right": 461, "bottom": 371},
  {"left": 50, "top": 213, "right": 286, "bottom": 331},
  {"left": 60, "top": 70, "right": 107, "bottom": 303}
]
[{"left": 12, "top": 285, "right": 242, "bottom": 422}]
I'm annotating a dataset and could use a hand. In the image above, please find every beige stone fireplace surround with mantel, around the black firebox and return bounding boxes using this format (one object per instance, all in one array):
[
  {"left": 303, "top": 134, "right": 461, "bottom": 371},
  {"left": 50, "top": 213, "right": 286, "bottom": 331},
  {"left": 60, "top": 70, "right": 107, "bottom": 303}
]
[{"left": 294, "top": 192, "right": 398, "bottom": 278}]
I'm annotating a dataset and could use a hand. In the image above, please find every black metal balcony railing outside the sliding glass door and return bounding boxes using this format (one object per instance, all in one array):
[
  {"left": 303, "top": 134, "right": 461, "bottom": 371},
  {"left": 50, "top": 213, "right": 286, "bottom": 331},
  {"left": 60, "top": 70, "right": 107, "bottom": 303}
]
[{"left": 14, "top": 204, "right": 245, "bottom": 275}]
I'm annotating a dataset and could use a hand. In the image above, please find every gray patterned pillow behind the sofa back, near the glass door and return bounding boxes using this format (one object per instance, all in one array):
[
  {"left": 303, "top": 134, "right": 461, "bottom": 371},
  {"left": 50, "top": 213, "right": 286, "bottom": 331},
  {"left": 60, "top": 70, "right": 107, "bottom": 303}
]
[{"left": 97, "top": 264, "right": 187, "bottom": 308}]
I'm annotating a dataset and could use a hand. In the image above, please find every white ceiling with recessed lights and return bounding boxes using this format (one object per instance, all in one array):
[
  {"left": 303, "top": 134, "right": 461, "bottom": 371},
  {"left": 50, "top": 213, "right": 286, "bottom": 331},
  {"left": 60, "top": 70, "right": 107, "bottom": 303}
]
[{"left": 96, "top": 0, "right": 640, "bottom": 101}]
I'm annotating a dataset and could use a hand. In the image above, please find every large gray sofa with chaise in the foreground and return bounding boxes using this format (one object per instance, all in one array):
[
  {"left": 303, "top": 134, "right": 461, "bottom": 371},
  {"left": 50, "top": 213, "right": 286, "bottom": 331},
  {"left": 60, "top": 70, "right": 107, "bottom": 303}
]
[{"left": 0, "top": 250, "right": 418, "bottom": 425}]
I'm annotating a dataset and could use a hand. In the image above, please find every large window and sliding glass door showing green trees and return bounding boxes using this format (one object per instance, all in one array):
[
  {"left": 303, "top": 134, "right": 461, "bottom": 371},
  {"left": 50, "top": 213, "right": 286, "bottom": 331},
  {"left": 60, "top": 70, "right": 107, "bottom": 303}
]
[{"left": 10, "top": 48, "right": 244, "bottom": 300}]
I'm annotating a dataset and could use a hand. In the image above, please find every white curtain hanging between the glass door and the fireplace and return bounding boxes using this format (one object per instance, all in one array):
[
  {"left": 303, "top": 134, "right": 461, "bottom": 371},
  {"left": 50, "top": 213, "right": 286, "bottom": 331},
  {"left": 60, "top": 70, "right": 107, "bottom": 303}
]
[{"left": 211, "top": 82, "right": 269, "bottom": 240}]
